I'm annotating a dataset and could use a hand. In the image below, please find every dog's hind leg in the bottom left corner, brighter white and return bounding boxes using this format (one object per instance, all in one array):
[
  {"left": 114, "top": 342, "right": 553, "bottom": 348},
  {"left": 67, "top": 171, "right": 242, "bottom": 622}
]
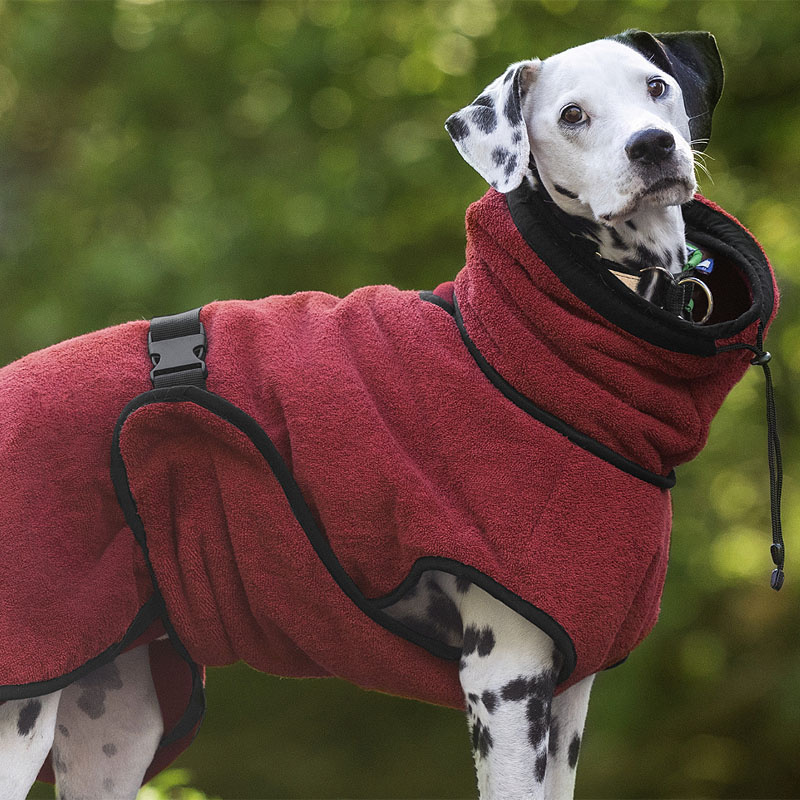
[{"left": 0, "top": 692, "right": 61, "bottom": 800}]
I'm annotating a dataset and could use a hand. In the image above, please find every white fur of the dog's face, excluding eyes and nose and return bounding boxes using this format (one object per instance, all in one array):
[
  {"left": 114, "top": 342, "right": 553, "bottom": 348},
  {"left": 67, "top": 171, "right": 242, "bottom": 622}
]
[{"left": 522, "top": 41, "right": 696, "bottom": 225}]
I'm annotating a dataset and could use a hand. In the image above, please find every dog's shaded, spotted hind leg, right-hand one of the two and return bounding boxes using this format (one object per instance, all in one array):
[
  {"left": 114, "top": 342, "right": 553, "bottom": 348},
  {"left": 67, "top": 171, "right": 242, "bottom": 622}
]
[{"left": 53, "top": 646, "right": 163, "bottom": 800}]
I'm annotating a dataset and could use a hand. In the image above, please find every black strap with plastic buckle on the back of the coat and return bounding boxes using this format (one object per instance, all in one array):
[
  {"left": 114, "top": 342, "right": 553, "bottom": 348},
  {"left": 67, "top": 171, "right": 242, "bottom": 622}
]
[{"left": 147, "top": 308, "right": 208, "bottom": 389}]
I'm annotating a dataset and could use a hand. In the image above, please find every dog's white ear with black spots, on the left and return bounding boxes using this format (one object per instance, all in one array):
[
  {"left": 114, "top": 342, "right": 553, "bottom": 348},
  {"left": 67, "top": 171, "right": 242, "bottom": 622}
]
[{"left": 444, "top": 59, "right": 541, "bottom": 192}]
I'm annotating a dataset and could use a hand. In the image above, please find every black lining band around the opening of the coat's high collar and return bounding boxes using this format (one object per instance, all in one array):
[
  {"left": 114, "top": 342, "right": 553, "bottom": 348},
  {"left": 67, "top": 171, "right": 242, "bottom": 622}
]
[{"left": 505, "top": 182, "right": 775, "bottom": 356}]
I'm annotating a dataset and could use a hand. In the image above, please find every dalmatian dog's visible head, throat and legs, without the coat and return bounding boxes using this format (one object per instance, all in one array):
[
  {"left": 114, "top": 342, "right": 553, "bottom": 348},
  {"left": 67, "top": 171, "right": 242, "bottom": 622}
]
[{"left": 0, "top": 31, "right": 721, "bottom": 800}]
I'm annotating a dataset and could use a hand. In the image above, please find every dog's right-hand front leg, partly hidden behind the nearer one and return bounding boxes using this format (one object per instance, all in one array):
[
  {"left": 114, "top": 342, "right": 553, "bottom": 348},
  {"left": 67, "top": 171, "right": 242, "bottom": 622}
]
[{"left": 544, "top": 675, "right": 594, "bottom": 800}]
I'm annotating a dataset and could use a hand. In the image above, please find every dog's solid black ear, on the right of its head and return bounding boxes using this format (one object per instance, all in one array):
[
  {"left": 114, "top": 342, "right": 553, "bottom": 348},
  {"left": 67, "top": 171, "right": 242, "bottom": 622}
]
[{"left": 610, "top": 30, "right": 724, "bottom": 150}]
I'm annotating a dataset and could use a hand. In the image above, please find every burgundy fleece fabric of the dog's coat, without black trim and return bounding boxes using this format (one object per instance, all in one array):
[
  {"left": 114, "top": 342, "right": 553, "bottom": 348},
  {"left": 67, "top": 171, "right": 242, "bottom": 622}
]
[{"left": 0, "top": 190, "right": 774, "bottom": 777}]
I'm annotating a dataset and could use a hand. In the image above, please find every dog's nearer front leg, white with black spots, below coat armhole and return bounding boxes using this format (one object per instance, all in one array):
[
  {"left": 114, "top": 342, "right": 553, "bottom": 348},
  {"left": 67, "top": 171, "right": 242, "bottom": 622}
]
[{"left": 460, "top": 586, "right": 567, "bottom": 800}]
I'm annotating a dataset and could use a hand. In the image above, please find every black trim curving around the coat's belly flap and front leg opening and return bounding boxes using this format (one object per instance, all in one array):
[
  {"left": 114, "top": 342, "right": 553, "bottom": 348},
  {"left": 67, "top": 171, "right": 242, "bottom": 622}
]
[{"left": 112, "top": 386, "right": 577, "bottom": 683}]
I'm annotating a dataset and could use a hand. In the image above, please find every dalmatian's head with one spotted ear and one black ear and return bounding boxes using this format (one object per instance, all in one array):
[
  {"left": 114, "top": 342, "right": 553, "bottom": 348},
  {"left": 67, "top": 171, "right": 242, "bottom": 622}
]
[{"left": 445, "top": 30, "right": 723, "bottom": 223}]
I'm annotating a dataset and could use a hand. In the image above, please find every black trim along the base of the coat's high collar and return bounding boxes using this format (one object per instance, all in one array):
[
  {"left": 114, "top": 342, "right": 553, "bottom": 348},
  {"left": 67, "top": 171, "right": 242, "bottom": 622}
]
[{"left": 420, "top": 292, "right": 676, "bottom": 489}]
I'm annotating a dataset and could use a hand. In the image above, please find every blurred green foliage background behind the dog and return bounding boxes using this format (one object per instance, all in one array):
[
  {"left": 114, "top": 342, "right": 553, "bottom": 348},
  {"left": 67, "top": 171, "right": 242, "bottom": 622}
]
[{"left": 0, "top": 0, "right": 800, "bottom": 799}]
